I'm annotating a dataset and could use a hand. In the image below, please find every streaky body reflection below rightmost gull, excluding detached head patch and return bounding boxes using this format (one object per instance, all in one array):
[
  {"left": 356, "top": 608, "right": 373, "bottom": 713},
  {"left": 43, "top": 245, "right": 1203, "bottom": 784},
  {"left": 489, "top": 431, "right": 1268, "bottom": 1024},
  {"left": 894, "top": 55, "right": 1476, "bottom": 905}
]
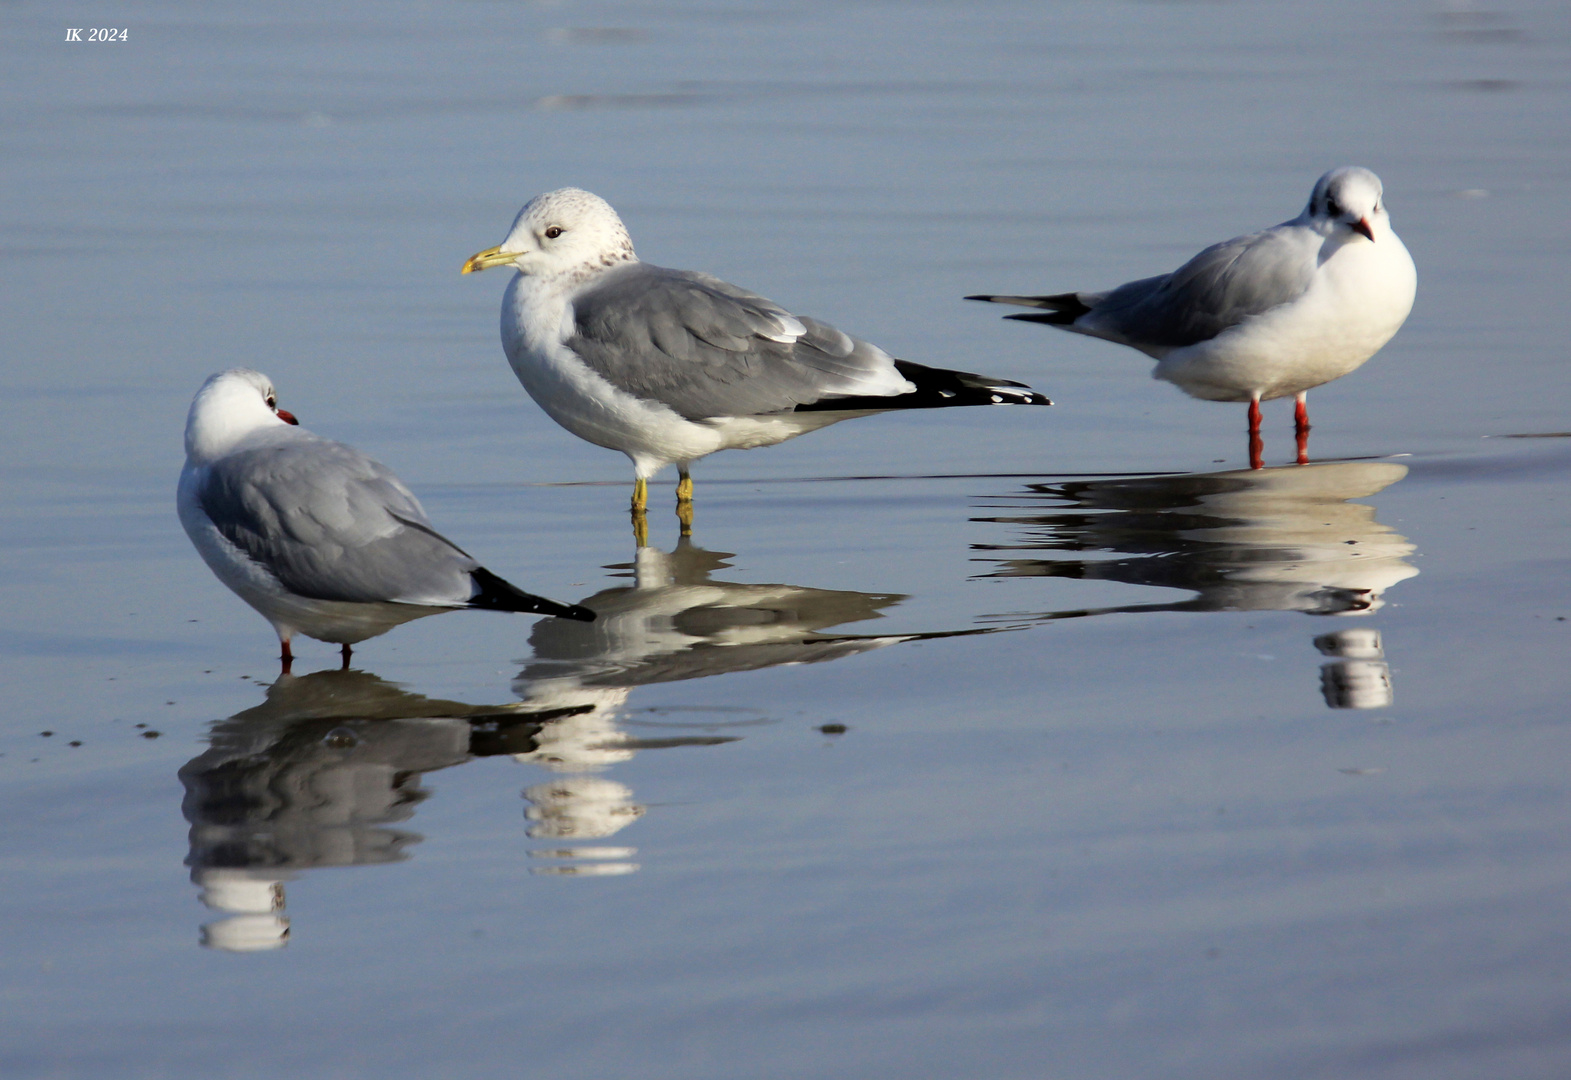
[{"left": 977, "top": 462, "right": 1419, "bottom": 618}]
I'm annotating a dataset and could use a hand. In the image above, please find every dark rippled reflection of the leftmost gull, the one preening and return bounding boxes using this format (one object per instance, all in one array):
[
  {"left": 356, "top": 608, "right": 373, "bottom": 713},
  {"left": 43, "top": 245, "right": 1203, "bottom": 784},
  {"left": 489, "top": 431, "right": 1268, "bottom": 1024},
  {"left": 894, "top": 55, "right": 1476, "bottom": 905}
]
[{"left": 179, "top": 671, "right": 539, "bottom": 951}]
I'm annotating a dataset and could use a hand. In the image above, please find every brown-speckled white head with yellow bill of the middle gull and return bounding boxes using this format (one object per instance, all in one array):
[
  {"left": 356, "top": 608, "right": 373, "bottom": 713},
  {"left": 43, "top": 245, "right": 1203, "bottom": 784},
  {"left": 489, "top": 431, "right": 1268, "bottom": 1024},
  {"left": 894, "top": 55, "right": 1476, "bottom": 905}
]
[{"left": 462, "top": 187, "right": 638, "bottom": 278}]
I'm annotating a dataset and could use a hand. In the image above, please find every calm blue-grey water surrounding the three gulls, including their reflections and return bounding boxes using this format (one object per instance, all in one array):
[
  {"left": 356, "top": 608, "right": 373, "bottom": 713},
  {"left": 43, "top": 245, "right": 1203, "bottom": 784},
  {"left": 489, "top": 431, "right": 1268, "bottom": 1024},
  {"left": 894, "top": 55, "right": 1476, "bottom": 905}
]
[{"left": 0, "top": 0, "right": 1571, "bottom": 1080}]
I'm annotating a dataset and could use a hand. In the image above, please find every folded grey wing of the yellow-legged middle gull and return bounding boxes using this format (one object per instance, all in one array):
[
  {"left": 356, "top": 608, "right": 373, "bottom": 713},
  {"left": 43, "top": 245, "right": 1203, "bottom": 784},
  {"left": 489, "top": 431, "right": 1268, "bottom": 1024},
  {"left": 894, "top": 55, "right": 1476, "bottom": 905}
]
[{"left": 567, "top": 263, "right": 910, "bottom": 420}]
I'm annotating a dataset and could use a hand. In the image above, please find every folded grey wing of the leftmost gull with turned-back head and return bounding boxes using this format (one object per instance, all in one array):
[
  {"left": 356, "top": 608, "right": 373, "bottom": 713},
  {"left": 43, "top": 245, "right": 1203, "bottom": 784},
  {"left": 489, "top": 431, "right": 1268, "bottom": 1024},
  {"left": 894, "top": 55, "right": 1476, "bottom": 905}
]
[{"left": 196, "top": 432, "right": 478, "bottom": 605}]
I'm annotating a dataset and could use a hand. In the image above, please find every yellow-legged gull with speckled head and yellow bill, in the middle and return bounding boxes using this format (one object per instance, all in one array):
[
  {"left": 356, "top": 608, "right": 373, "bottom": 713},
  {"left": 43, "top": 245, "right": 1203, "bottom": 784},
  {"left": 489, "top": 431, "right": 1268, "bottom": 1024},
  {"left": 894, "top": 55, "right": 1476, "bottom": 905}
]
[{"left": 463, "top": 187, "right": 1051, "bottom": 540}]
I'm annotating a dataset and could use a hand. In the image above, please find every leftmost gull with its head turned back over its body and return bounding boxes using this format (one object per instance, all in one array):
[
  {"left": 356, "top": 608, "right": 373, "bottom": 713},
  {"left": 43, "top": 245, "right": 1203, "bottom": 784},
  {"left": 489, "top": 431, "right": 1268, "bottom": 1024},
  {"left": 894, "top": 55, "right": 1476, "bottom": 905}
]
[{"left": 178, "top": 375, "right": 594, "bottom": 673}]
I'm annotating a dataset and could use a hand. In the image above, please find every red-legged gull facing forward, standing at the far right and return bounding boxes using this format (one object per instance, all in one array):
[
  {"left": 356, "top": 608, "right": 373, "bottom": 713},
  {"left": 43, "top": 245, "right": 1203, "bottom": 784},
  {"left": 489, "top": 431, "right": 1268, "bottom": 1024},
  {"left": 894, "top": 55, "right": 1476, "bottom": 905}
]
[{"left": 966, "top": 165, "right": 1417, "bottom": 468}]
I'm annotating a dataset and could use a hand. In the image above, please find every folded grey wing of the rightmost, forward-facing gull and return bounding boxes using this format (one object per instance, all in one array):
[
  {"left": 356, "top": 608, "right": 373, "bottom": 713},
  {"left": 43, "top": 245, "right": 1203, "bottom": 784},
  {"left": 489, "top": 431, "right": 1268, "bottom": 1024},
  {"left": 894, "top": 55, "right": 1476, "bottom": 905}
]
[{"left": 1074, "top": 225, "right": 1318, "bottom": 351}]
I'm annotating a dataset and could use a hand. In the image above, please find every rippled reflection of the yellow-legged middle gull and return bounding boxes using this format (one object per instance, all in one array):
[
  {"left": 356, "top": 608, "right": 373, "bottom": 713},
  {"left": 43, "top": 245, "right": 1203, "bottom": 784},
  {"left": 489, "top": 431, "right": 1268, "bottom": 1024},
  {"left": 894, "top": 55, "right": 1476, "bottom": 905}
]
[{"left": 514, "top": 538, "right": 976, "bottom": 874}]
